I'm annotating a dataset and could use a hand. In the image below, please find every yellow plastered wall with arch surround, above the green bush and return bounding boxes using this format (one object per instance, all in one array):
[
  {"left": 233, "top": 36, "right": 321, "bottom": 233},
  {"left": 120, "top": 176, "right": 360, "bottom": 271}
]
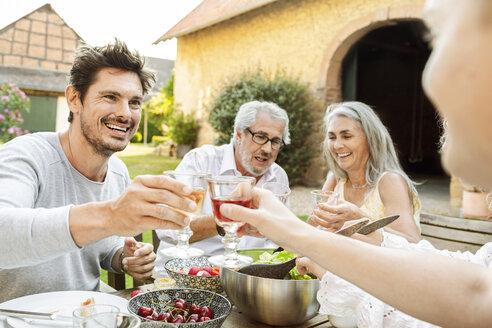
[{"left": 174, "top": 0, "right": 424, "bottom": 181}]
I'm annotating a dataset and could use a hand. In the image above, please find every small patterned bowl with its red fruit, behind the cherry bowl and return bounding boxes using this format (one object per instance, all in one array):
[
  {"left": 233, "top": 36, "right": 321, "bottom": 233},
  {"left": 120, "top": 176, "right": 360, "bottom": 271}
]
[{"left": 164, "top": 256, "right": 222, "bottom": 293}]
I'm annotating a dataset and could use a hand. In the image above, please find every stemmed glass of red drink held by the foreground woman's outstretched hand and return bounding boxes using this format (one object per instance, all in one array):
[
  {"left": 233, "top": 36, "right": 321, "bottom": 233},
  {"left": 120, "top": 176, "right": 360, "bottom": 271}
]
[{"left": 207, "top": 176, "right": 255, "bottom": 268}]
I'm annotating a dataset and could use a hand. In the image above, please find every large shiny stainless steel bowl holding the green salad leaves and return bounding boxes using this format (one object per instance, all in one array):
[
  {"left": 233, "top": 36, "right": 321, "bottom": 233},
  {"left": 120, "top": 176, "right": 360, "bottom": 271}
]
[{"left": 220, "top": 268, "right": 319, "bottom": 326}]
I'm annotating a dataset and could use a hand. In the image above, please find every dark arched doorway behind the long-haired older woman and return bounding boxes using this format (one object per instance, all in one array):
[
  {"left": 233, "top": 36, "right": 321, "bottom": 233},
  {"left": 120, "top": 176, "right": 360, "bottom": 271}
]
[{"left": 341, "top": 20, "right": 444, "bottom": 175}]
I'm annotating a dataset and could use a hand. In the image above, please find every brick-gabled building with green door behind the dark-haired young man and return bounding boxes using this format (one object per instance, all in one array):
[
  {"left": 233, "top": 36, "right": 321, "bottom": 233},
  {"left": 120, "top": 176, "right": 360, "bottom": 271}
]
[{"left": 0, "top": 4, "right": 174, "bottom": 132}]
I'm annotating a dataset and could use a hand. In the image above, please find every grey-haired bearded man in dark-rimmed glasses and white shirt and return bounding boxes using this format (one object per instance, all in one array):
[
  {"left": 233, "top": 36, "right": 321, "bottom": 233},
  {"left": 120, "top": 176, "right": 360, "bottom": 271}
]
[{"left": 156, "top": 101, "right": 290, "bottom": 273}]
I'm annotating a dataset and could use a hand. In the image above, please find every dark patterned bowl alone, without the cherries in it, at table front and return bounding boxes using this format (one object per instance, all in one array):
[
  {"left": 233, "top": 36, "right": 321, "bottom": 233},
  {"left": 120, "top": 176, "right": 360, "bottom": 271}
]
[{"left": 128, "top": 288, "right": 232, "bottom": 328}]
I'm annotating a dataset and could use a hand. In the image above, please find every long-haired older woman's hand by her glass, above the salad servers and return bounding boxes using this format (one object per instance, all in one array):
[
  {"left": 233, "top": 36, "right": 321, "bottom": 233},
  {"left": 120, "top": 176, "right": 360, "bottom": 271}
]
[{"left": 308, "top": 200, "right": 367, "bottom": 230}]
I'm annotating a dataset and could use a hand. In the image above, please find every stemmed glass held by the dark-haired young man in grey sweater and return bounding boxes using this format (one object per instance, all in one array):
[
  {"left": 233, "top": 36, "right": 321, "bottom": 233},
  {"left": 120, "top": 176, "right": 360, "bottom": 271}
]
[{"left": 161, "top": 171, "right": 210, "bottom": 259}]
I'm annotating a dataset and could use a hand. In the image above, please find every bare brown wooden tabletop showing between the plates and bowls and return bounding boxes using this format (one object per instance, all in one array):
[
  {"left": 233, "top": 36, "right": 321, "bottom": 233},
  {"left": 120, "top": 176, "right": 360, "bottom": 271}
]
[{"left": 110, "top": 284, "right": 333, "bottom": 328}]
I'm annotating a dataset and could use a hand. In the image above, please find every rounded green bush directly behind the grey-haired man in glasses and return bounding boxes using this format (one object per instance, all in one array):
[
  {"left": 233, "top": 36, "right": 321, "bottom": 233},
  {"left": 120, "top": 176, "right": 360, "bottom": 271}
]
[{"left": 209, "top": 73, "right": 314, "bottom": 185}]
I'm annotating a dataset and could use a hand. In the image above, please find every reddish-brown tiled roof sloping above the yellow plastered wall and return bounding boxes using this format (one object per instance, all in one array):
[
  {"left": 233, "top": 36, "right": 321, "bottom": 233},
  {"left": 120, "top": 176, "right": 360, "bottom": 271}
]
[{"left": 154, "top": 0, "right": 277, "bottom": 44}]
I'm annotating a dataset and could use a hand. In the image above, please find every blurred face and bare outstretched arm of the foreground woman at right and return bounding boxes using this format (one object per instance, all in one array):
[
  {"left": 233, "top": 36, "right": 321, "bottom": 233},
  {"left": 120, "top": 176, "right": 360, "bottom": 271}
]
[{"left": 220, "top": 0, "right": 492, "bottom": 327}]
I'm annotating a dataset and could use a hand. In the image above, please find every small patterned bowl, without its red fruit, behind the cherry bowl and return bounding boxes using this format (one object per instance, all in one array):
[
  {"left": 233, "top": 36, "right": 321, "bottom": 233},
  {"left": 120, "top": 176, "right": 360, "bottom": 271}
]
[{"left": 164, "top": 256, "right": 222, "bottom": 293}]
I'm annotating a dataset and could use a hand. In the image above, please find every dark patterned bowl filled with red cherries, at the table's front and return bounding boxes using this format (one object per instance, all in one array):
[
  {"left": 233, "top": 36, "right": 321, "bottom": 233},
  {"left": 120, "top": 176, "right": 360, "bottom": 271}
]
[{"left": 128, "top": 288, "right": 232, "bottom": 328}]
